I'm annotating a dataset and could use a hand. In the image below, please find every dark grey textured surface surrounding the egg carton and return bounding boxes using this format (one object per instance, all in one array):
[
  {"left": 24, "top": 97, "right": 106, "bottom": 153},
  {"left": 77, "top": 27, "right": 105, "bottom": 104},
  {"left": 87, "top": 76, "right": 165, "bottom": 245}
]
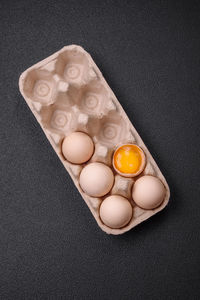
[{"left": 0, "top": 0, "right": 200, "bottom": 300}]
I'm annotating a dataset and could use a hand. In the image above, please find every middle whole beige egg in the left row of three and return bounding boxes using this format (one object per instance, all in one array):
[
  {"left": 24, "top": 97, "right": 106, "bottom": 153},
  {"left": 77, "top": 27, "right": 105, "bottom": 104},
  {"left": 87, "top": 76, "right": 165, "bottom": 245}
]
[{"left": 80, "top": 162, "right": 114, "bottom": 197}]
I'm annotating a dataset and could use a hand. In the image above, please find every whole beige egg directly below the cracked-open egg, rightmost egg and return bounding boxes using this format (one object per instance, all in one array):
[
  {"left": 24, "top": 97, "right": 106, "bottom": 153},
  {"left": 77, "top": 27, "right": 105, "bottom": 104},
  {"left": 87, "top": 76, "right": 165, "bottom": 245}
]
[{"left": 132, "top": 175, "right": 166, "bottom": 209}]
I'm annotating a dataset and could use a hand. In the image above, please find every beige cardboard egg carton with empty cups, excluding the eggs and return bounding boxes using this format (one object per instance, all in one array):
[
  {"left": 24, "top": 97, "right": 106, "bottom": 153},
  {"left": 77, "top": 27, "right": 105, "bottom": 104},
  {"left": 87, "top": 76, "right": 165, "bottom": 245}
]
[{"left": 19, "top": 45, "right": 170, "bottom": 234}]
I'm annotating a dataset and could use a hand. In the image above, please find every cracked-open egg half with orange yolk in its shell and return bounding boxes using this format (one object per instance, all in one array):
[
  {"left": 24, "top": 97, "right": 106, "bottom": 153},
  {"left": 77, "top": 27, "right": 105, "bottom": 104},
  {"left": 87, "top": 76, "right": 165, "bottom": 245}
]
[{"left": 113, "top": 145, "right": 144, "bottom": 174}]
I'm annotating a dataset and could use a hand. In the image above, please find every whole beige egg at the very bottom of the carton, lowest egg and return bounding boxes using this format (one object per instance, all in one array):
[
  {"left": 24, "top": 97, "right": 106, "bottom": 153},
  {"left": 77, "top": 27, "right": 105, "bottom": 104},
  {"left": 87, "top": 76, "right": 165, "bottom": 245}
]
[{"left": 99, "top": 195, "right": 133, "bottom": 228}]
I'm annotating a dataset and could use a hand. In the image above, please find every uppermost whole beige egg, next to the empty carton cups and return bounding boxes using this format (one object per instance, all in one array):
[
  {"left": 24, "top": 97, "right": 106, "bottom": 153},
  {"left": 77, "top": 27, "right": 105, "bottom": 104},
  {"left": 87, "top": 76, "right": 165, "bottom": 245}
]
[{"left": 62, "top": 132, "right": 94, "bottom": 164}]
